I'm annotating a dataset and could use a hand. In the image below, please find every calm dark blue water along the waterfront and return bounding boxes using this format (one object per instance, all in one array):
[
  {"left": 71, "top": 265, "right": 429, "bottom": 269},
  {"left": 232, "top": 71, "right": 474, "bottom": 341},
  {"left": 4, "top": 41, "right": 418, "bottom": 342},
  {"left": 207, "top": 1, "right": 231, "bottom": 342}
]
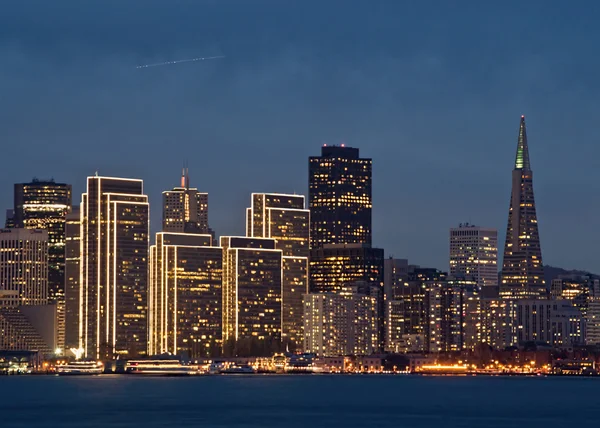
[{"left": 0, "top": 375, "right": 600, "bottom": 428}]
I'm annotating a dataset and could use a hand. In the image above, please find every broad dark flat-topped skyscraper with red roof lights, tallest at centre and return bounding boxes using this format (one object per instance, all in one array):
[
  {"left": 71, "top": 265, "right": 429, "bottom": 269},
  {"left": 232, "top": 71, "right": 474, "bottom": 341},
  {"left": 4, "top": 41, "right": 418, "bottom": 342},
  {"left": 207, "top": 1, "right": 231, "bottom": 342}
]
[{"left": 308, "top": 145, "right": 372, "bottom": 248}]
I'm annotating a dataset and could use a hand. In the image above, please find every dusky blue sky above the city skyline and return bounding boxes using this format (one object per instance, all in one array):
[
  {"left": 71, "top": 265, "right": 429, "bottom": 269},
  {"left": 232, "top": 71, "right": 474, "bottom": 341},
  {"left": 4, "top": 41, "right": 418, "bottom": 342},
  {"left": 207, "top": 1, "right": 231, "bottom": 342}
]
[{"left": 0, "top": 0, "right": 600, "bottom": 273}]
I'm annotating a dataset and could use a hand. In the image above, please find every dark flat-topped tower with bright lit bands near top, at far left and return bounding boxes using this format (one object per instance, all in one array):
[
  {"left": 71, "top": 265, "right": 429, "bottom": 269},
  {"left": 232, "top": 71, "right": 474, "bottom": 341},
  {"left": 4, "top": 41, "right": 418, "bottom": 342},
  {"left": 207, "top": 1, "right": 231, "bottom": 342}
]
[{"left": 13, "top": 179, "right": 71, "bottom": 349}]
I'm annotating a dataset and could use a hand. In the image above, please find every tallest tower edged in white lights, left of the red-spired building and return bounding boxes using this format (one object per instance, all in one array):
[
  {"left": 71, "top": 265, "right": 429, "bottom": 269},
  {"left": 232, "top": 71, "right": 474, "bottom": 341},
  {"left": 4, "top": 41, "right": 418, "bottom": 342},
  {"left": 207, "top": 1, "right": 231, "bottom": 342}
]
[{"left": 79, "top": 176, "right": 149, "bottom": 358}]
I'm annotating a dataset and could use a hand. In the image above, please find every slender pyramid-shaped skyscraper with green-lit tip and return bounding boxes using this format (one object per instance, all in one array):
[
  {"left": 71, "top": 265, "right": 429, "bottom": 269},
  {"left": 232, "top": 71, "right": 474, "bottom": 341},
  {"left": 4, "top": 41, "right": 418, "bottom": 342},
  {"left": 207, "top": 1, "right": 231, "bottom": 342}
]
[{"left": 500, "top": 116, "right": 547, "bottom": 298}]
